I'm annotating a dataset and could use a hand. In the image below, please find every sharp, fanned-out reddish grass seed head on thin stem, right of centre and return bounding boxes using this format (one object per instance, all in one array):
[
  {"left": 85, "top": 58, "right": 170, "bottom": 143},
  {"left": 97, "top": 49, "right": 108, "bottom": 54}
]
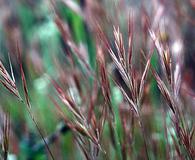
[{"left": 98, "top": 14, "right": 153, "bottom": 159}]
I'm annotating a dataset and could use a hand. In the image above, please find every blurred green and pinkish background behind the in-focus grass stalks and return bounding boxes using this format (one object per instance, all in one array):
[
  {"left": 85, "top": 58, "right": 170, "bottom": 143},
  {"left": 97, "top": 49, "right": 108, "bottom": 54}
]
[{"left": 0, "top": 0, "right": 195, "bottom": 160}]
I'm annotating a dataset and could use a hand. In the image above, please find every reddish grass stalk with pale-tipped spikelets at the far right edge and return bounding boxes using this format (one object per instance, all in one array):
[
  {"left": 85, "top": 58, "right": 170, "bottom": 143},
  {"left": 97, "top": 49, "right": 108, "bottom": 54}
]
[{"left": 149, "top": 27, "right": 195, "bottom": 159}]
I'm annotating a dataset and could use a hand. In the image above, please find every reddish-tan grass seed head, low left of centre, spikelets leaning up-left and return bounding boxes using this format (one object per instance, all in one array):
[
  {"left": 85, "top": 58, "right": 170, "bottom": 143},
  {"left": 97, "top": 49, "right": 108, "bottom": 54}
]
[{"left": 52, "top": 76, "right": 105, "bottom": 158}]
